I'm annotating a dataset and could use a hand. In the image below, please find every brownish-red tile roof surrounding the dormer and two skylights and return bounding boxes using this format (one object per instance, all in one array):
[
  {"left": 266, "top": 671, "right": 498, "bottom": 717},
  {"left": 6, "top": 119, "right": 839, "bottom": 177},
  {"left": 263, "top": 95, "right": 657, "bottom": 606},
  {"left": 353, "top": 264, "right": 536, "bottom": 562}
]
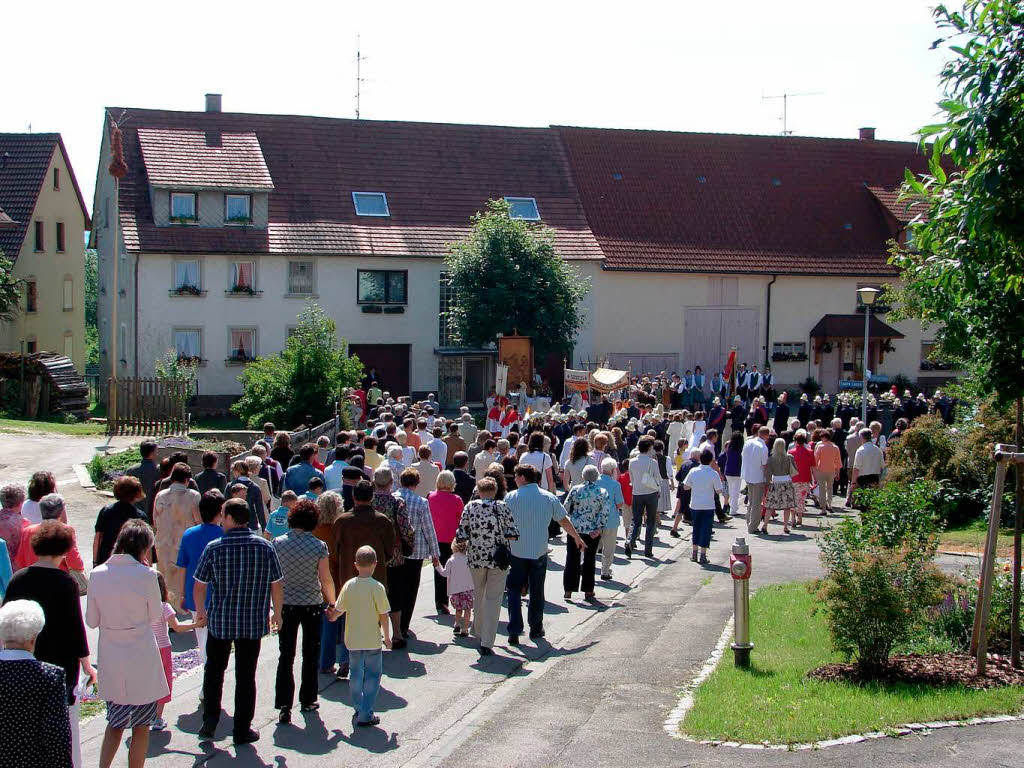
[{"left": 109, "top": 108, "right": 601, "bottom": 259}]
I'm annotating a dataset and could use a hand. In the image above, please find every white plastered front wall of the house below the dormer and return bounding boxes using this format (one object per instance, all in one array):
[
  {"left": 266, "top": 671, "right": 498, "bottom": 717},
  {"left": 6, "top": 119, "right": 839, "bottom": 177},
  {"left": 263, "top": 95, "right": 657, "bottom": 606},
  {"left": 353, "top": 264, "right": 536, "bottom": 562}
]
[{"left": 139, "top": 254, "right": 441, "bottom": 395}]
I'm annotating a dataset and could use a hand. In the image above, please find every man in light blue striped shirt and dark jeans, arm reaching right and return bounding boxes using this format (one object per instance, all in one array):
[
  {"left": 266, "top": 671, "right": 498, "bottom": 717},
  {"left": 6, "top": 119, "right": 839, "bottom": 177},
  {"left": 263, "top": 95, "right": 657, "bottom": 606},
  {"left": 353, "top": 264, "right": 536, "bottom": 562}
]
[{"left": 505, "top": 464, "right": 586, "bottom": 645}]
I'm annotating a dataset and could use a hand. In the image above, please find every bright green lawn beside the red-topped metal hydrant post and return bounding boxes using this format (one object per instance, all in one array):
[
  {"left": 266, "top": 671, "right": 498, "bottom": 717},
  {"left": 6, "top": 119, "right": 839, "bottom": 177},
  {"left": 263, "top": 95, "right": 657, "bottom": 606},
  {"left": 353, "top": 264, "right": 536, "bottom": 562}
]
[{"left": 680, "top": 584, "right": 1024, "bottom": 743}]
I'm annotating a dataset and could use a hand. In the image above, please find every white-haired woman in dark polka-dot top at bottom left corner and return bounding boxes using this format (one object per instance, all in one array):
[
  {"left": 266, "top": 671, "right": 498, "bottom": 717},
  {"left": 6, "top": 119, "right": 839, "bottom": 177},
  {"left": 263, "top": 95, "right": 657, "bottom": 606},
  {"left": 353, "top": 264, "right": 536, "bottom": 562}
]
[{"left": 0, "top": 600, "right": 74, "bottom": 768}]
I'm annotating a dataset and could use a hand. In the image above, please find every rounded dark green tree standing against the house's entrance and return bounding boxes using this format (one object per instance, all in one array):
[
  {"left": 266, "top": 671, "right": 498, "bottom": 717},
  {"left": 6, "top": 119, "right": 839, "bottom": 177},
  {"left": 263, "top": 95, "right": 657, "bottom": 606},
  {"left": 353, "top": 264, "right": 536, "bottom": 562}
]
[{"left": 442, "top": 200, "right": 589, "bottom": 355}]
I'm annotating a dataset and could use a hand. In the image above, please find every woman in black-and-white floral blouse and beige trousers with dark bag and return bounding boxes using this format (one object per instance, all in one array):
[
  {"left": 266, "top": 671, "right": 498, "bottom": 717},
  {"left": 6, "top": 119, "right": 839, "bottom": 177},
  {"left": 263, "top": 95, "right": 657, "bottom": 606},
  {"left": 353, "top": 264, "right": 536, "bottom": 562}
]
[{"left": 456, "top": 477, "right": 519, "bottom": 656}]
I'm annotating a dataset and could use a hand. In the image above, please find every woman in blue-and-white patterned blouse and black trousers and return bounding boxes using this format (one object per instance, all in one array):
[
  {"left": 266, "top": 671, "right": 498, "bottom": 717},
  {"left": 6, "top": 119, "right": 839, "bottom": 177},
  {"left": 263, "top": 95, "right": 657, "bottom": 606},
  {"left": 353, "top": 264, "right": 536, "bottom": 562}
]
[{"left": 562, "top": 466, "right": 611, "bottom": 602}]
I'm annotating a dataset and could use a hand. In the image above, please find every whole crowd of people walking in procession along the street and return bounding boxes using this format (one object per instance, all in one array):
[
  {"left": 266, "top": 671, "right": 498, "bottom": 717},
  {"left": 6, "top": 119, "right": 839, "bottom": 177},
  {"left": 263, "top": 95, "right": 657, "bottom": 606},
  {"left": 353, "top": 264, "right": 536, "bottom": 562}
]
[{"left": 0, "top": 371, "right": 950, "bottom": 768}]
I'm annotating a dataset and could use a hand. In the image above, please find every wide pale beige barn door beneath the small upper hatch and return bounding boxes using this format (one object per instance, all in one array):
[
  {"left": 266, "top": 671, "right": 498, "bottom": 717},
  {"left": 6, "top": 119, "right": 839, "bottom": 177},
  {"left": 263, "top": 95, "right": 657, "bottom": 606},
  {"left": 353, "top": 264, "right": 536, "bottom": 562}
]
[{"left": 683, "top": 307, "right": 761, "bottom": 377}]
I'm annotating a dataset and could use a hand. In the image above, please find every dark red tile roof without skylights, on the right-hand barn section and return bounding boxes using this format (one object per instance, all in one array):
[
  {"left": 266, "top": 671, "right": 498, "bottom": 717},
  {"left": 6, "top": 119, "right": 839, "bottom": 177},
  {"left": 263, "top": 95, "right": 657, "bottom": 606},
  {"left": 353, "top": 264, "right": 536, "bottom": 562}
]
[{"left": 557, "top": 127, "right": 927, "bottom": 275}]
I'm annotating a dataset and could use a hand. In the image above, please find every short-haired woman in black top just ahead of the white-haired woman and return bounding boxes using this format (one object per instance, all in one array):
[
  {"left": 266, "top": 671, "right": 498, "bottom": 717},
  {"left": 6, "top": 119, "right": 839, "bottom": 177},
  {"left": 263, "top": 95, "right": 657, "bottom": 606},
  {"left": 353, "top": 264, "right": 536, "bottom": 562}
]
[{"left": 4, "top": 520, "right": 96, "bottom": 768}]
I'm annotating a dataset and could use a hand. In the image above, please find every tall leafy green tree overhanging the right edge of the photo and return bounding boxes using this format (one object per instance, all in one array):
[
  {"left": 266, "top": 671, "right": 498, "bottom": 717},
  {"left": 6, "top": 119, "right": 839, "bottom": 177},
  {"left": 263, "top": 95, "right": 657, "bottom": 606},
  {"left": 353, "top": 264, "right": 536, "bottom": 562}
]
[{"left": 893, "top": 0, "right": 1024, "bottom": 664}]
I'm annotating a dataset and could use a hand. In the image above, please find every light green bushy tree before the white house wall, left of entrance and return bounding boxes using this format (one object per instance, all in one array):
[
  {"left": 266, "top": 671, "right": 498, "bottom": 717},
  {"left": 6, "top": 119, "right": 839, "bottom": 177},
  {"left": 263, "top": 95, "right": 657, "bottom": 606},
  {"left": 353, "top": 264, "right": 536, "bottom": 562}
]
[{"left": 231, "top": 301, "right": 362, "bottom": 429}]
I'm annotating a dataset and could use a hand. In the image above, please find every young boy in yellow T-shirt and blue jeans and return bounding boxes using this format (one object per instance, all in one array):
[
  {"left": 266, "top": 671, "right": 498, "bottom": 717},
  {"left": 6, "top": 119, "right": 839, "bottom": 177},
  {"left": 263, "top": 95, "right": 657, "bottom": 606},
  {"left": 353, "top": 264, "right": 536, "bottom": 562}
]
[{"left": 328, "top": 546, "right": 391, "bottom": 727}]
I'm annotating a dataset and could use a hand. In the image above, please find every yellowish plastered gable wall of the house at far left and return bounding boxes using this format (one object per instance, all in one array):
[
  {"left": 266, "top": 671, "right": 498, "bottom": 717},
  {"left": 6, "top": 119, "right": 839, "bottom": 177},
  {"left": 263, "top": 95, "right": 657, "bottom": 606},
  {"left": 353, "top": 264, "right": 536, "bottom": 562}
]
[{"left": 0, "top": 147, "right": 85, "bottom": 372}]
